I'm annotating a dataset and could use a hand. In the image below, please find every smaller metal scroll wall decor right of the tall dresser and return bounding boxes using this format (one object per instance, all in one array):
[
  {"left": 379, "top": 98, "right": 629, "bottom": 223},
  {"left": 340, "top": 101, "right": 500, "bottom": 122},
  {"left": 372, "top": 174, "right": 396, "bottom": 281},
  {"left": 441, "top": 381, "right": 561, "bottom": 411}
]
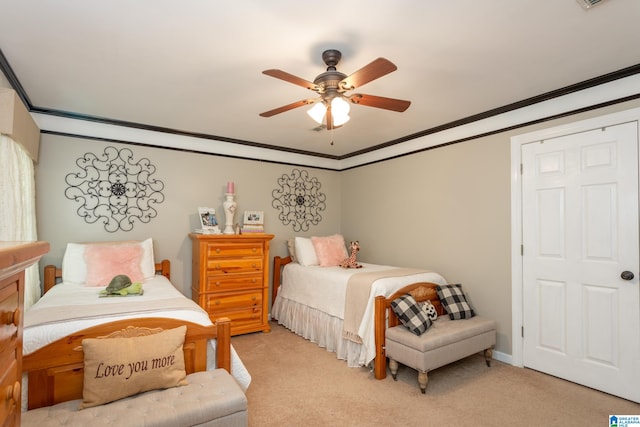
[{"left": 271, "top": 169, "right": 327, "bottom": 231}]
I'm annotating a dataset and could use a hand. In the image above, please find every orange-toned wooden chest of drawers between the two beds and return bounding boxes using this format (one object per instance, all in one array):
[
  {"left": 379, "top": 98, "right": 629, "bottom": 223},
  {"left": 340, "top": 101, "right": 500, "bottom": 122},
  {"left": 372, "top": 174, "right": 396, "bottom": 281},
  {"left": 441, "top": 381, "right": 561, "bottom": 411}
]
[{"left": 189, "top": 233, "right": 274, "bottom": 335}]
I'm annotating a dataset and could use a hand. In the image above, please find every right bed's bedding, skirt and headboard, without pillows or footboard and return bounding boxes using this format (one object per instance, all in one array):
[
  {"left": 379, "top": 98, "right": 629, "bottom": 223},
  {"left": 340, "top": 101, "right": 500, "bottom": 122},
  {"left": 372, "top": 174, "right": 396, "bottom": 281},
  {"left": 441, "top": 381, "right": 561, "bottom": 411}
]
[{"left": 271, "top": 241, "right": 447, "bottom": 367}]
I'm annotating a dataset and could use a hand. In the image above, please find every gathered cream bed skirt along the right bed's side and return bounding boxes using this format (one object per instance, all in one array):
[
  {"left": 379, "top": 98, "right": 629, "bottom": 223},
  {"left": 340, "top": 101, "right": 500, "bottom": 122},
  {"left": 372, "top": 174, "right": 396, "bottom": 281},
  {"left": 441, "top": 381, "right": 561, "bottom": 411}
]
[{"left": 272, "top": 297, "right": 367, "bottom": 368}]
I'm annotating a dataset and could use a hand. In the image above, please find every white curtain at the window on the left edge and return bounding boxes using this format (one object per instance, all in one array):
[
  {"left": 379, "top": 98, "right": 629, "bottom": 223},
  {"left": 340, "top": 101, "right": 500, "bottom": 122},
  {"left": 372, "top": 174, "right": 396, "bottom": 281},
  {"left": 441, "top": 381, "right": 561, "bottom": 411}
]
[{"left": 0, "top": 134, "right": 41, "bottom": 309}]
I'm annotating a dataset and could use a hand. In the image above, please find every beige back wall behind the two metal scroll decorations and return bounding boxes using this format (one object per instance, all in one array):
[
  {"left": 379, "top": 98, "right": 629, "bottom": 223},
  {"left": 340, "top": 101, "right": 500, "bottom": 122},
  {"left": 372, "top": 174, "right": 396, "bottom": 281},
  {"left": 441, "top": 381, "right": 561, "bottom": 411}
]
[{"left": 36, "top": 134, "right": 342, "bottom": 296}]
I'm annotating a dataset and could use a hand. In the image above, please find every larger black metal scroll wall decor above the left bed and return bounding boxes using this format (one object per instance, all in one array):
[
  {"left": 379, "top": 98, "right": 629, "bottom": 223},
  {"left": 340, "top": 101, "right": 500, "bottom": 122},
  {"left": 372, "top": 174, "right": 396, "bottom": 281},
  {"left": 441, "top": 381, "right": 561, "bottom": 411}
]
[{"left": 64, "top": 147, "right": 164, "bottom": 233}]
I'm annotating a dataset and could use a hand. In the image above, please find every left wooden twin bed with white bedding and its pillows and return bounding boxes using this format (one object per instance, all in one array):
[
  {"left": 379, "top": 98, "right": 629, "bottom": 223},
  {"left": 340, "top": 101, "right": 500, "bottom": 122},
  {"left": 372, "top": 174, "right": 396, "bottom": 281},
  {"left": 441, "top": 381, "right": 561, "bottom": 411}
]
[{"left": 23, "top": 239, "right": 251, "bottom": 409}]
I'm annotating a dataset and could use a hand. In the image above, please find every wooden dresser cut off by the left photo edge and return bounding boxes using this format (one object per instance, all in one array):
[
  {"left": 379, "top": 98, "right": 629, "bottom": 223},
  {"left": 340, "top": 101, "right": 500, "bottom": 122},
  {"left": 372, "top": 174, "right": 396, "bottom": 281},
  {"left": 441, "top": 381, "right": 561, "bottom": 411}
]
[{"left": 0, "top": 242, "right": 49, "bottom": 427}]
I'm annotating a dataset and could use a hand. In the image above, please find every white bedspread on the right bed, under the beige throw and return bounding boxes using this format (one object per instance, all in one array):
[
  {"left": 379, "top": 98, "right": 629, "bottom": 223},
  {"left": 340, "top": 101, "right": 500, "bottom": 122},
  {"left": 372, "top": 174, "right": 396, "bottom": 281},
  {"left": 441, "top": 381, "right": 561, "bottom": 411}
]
[{"left": 274, "top": 263, "right": 447, "bottom": 366}]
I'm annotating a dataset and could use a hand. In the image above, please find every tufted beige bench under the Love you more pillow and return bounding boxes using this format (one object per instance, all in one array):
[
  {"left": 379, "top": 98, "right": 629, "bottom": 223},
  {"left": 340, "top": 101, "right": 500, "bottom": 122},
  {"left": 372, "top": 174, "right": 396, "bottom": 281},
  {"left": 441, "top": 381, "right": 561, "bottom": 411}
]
[{"left": 22, "top": 369, "right": 248, "bottom": 427}]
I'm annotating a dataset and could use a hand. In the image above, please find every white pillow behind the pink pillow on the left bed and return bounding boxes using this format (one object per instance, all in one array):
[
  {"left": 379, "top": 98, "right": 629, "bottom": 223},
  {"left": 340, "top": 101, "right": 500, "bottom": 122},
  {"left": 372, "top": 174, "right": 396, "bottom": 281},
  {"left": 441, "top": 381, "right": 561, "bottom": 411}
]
[{"left": 62, "top": 238, "right": 156, "bottom": 285}]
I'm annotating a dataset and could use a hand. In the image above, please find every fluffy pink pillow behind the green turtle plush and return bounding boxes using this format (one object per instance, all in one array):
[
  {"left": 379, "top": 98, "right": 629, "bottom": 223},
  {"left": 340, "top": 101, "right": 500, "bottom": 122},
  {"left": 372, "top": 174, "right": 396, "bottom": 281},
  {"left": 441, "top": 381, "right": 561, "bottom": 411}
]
[{"left": 84, "top": 244, "right": 144, "bottom": 286}]
